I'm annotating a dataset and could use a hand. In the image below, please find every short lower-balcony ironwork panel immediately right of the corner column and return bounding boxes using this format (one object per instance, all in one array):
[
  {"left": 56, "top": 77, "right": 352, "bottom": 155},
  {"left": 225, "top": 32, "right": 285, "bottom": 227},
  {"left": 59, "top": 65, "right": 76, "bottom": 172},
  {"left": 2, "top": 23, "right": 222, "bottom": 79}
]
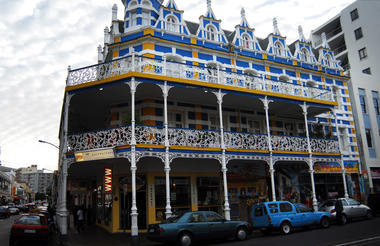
[{"left": 135, "top": 126, "right": 165, "bottom": 145}]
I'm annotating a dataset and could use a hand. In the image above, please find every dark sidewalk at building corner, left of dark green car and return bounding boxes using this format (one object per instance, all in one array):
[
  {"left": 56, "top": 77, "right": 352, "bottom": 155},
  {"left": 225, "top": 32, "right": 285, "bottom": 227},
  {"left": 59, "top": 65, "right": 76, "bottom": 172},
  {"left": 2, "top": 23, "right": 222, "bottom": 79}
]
[{"left": 49, "top": 225, "right": 157, "bottom": 246}]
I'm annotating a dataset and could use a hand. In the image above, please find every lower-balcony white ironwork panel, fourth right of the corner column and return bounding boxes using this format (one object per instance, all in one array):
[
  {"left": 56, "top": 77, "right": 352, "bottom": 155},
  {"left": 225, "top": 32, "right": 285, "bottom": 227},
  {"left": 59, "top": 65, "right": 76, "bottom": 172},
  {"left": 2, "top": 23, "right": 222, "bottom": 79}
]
[{"left": 271, "top": 135, "right": 308, "bottom": 152}]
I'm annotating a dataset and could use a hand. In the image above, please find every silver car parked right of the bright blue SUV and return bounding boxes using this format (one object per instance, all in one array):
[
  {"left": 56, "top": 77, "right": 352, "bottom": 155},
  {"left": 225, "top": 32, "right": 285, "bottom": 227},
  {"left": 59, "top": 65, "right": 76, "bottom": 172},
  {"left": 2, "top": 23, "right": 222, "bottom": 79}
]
[{"left": 319, "top": 198, "right": 373, "bottom": 224}]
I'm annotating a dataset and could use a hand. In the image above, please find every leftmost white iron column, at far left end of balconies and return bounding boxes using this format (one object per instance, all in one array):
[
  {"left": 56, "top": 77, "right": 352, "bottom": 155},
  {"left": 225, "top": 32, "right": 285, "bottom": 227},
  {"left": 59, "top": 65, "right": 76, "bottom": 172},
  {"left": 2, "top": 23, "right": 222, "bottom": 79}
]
[{"left": 57, "top": 93, "right": 72, "bottom": 239}]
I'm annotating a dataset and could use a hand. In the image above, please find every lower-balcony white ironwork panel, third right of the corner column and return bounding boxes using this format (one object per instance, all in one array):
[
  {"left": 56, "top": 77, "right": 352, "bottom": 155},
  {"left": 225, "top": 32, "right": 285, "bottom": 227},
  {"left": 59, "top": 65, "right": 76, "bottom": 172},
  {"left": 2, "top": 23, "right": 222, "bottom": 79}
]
[{"left": 224, "top": 132, "right": 268, "bottom": 150}]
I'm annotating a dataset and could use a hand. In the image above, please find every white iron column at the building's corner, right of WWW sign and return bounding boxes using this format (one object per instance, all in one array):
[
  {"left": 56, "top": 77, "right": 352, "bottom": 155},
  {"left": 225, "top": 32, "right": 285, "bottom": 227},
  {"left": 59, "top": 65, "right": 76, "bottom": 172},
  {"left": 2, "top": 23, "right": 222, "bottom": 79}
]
[{"left": 131, "top": 77, "right": 139, "bottom": 241}]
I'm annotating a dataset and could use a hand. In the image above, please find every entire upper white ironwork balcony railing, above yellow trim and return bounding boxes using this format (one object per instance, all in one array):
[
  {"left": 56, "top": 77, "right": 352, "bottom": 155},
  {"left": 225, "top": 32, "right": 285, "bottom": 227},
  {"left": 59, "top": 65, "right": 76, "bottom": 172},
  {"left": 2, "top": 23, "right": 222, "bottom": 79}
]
[{"left": 67, "top": 55, "right": 333, "bottom": 102}]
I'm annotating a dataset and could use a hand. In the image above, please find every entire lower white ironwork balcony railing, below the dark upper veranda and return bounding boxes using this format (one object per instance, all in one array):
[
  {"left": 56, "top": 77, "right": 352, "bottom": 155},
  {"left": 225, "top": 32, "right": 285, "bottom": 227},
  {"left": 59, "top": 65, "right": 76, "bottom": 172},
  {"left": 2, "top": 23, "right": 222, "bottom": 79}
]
[{"left": 68, "top": 125, "right": 339, "bottom": 153}]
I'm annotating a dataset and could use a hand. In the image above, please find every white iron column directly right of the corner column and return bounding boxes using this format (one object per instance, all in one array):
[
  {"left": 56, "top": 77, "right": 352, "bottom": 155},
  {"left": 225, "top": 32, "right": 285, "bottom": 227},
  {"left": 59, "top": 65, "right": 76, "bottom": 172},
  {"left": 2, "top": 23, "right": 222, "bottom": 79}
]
[{"left": 161, "top": 81, "right": 172, "bottom": 218}]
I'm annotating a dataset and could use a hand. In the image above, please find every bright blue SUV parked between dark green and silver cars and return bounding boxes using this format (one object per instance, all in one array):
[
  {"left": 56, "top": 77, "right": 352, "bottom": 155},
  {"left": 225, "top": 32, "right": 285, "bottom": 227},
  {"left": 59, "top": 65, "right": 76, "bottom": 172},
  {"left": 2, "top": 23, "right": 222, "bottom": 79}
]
[{"left": 251, "top": 201, "right": 330, "bottom": 234}]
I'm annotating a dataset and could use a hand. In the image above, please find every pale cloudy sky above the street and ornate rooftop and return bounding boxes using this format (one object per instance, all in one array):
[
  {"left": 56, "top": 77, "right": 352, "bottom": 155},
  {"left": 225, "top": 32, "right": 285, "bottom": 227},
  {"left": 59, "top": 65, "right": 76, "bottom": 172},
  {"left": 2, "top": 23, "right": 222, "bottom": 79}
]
[{"left": 0, "top": 0, "right": 354, "bottom": 171}]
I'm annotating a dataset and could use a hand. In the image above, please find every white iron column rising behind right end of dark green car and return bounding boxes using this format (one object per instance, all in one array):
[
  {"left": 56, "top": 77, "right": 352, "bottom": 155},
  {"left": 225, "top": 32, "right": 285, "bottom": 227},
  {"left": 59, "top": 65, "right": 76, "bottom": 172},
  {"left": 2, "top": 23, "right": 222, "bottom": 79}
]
[{"left": 215, "top": 89, "right": 231, "bottom": 220}]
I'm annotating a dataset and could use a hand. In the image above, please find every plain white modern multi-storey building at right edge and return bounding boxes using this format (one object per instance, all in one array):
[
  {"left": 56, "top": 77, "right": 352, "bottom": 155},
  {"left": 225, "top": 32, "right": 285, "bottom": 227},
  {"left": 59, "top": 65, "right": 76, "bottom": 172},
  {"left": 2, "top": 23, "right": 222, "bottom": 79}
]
[{"left": 311, "top": 0, "right": 380, "bottom": 192}]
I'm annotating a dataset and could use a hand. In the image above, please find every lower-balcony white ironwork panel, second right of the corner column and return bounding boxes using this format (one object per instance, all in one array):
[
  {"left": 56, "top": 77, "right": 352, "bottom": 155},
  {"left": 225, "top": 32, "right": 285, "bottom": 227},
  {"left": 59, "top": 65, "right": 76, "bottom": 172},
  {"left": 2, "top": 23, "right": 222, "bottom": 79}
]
[{"left": 168, "top": 128, "right": 220, "bottom": 148}]
